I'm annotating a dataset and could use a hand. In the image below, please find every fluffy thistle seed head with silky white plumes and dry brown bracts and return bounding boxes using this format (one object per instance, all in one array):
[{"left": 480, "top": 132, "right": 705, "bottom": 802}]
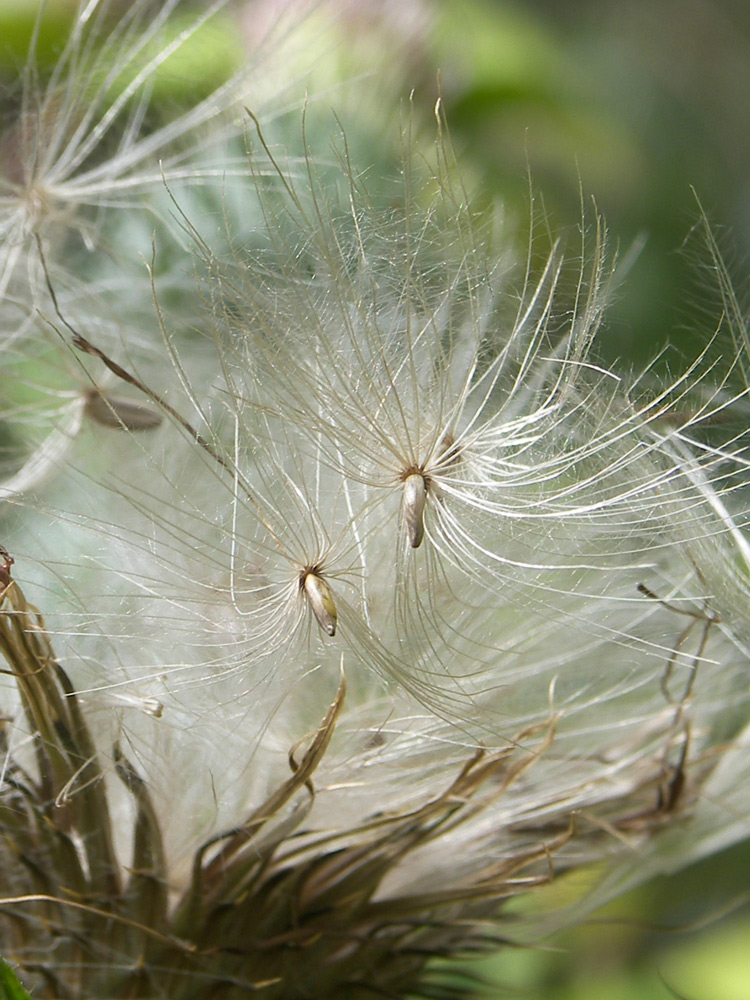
[{"left": 0, "top": 4, "right": 750, "bottom": 1000}]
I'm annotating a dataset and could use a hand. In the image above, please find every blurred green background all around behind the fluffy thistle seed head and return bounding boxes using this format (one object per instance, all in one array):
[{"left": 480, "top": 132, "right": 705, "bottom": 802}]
[{"left": 0, "top": 0, "right": 750, "bottom": 1000}]
